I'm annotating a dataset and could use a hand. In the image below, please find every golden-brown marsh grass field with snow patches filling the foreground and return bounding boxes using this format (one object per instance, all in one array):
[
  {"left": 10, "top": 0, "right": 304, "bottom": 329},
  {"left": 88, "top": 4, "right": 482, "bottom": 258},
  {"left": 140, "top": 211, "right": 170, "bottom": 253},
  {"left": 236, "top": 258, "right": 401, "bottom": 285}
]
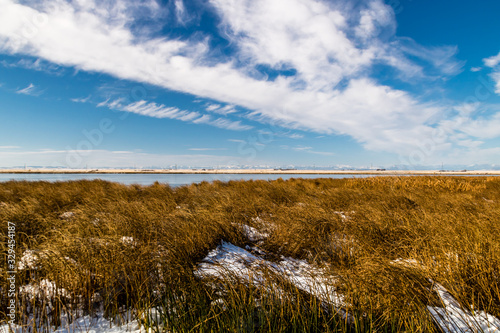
[{"left": 0, "top": 176, "right": 500, "bottom": 332}]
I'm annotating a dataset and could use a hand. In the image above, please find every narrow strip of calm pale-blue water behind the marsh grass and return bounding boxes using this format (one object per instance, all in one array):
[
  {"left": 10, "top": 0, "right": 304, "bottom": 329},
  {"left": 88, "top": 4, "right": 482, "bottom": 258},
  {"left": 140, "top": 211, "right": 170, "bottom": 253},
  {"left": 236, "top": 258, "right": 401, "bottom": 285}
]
[{"left": 0, "top": 174, "right": 373, "bottom": 187}]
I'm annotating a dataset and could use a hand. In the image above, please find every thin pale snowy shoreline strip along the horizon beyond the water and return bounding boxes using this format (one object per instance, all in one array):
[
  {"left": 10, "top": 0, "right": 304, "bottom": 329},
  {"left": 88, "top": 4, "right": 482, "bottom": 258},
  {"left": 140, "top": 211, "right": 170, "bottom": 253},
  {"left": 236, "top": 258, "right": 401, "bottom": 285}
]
[{"left": 0, "top": 169, "right": 500, "bottom": 176}]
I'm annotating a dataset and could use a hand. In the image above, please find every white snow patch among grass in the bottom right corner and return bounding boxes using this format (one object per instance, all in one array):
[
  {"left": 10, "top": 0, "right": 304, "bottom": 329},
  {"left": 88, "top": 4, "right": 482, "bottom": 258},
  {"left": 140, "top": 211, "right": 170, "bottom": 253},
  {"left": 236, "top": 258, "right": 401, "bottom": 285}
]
[{"left": 427, "top": 283, "right": 500, "bottom": 333}]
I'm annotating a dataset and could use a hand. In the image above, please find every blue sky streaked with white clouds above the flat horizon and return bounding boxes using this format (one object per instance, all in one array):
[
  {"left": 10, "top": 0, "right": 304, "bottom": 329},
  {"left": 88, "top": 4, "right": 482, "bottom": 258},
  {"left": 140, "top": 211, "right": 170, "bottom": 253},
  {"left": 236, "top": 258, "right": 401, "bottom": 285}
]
[{"left": 0, "top": 0, "right": 500, "bottom": 169}]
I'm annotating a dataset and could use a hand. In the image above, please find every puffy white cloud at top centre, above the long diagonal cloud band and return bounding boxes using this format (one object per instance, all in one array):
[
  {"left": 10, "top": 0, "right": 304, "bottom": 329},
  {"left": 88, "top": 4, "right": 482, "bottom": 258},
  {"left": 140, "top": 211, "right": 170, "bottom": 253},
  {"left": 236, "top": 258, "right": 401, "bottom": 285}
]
[{"left": 210, "top": 0, "right": 375, "bottom": 90}]
